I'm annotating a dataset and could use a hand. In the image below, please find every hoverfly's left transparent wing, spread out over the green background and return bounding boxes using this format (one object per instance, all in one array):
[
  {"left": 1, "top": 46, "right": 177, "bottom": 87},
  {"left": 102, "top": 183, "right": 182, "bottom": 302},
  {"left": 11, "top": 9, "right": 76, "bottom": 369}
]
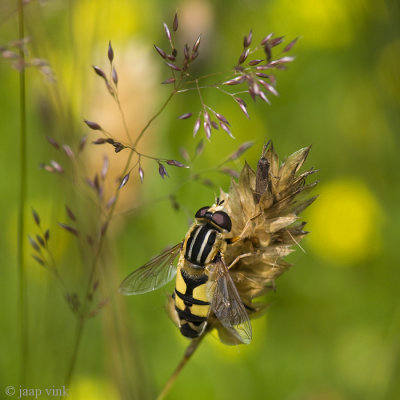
[{"left": 119, "top": 242, "right": 182, "bottom": 296}]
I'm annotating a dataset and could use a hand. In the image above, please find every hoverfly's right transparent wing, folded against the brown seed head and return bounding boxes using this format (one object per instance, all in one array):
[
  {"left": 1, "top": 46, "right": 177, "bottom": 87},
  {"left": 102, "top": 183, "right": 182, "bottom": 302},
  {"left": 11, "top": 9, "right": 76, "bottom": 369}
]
[{"left": 211, "top": 260, "right": 252, "bottom": 344}]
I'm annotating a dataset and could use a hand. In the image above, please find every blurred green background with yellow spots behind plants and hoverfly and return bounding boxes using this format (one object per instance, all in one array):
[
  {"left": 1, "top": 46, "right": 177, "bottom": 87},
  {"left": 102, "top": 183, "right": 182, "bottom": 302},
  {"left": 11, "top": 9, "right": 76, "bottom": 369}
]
[{"left": 0, "top": 0, "right": 400, "bottom": 400}]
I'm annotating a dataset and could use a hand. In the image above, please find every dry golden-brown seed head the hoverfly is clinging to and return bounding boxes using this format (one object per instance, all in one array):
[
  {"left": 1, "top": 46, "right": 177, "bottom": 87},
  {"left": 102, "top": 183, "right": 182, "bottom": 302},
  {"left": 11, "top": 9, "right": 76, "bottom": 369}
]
[{"left": 212, "top": 142, "right": 318, "bottom": 344}]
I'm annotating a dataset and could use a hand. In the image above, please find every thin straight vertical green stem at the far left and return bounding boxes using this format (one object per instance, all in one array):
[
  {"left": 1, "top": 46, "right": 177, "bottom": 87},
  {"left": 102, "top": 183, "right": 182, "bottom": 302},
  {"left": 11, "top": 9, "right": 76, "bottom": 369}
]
[{"left": 17, "top": 0, "right": 28, "bottom": 384}]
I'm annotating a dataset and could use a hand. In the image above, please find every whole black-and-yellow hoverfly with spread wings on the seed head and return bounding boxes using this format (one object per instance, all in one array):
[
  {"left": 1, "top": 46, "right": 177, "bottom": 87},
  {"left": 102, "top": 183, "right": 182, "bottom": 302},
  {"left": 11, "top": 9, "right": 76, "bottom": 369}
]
[{"left": 119, "top": 199, "right": 252, "bottom": 343}]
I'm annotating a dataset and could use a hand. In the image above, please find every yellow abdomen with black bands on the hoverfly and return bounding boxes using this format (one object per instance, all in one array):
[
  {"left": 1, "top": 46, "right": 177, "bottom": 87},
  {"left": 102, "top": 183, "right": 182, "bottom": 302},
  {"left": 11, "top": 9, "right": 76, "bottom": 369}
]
[{"left": 173, "top": 268, "right": 210, "bottom": 339}]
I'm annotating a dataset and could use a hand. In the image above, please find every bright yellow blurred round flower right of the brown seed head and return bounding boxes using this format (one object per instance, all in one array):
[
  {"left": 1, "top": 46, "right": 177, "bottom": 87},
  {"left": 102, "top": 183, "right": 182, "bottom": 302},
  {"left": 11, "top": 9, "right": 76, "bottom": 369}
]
[{"left": 307, "top": 179, "right": 382, "bottom": 264}]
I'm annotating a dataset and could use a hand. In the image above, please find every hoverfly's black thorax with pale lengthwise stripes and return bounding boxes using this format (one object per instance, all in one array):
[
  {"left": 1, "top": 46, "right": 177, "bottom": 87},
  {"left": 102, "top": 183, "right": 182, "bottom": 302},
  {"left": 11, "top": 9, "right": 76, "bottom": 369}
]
[{"left": 185, "top": 224, "right": 217, "bottom": 266}]
